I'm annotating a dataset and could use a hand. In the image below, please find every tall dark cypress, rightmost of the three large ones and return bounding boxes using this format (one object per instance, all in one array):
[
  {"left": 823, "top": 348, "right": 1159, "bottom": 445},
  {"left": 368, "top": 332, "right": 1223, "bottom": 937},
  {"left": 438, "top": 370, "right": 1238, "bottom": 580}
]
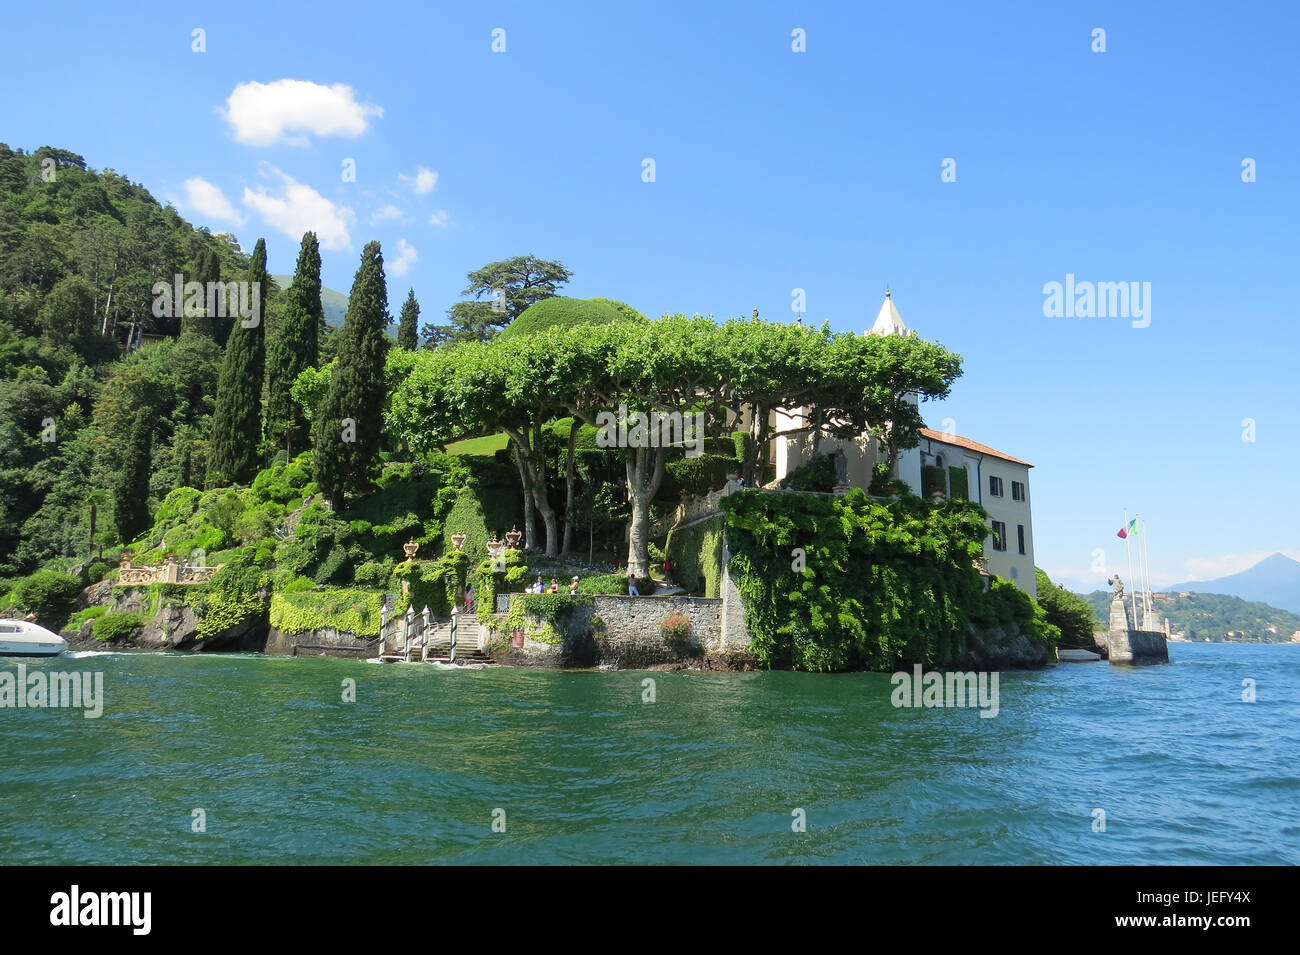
[{"left": 312, "top": 242, "right": 391, "bottom": 509}]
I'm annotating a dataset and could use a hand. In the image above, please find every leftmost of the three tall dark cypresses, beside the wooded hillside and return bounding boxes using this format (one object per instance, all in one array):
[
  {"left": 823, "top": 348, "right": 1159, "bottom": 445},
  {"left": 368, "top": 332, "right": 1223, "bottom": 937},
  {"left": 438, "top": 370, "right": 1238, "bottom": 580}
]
[{"left": 208, "top": 239, "right": 270, "bottom": 487}]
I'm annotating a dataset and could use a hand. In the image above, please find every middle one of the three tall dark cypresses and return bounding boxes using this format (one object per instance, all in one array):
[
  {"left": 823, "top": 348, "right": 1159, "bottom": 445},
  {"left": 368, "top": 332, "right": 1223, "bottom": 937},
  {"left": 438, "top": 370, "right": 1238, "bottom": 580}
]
[{"left": 267, "top": 233, "right": 325, "bottom": 457}]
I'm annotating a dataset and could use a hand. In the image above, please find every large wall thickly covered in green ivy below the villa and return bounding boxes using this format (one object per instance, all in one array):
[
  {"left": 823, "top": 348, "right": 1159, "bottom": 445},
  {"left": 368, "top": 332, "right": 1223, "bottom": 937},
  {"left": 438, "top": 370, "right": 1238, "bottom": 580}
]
[{"left": 723, "top": 490, "right": 1060, "bottom": 672}]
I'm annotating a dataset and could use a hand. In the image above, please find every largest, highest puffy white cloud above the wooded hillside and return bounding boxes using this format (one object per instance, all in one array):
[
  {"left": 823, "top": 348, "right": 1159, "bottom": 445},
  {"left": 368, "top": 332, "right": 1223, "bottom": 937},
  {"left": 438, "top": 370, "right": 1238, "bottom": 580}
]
[{"left": 217, "top": 79, "right": 379, "bottom": 147}]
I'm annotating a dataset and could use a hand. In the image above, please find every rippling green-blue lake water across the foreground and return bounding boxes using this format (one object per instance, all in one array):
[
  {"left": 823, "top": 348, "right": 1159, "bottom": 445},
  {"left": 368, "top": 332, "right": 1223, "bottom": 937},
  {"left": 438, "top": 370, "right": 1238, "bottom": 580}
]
[{"left": 0, "top": 644, "right": 1300, "bottom": 864}]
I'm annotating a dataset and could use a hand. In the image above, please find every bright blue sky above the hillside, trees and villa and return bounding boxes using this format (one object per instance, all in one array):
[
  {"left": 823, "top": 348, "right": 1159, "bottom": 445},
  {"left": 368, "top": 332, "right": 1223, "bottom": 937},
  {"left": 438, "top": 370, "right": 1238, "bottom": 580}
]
[{"left": 0, "top": 3, "right": 1300, "bottom": 589}]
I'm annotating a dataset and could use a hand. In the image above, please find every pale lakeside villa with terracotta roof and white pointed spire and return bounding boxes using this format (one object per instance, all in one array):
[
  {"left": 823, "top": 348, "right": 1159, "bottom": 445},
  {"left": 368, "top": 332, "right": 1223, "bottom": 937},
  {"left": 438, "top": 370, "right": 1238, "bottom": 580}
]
[{"left": 771, "top": 292, "right": 1039, "bottom": 598}]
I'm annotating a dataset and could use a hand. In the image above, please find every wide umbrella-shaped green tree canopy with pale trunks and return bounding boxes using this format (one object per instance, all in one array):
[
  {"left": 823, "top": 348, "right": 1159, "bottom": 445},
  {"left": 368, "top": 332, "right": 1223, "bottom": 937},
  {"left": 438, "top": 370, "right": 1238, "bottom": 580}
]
[{"left": 389, "top": 314, "right": 961, "bottom": 576}]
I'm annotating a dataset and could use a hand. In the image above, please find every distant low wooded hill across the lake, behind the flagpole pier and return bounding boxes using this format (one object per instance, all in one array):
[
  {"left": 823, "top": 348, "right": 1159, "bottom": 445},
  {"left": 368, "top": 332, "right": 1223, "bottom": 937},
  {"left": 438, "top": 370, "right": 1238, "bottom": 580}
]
[{"left": 1084, "top": 590, "right": 1300, "bottom": 643}]
